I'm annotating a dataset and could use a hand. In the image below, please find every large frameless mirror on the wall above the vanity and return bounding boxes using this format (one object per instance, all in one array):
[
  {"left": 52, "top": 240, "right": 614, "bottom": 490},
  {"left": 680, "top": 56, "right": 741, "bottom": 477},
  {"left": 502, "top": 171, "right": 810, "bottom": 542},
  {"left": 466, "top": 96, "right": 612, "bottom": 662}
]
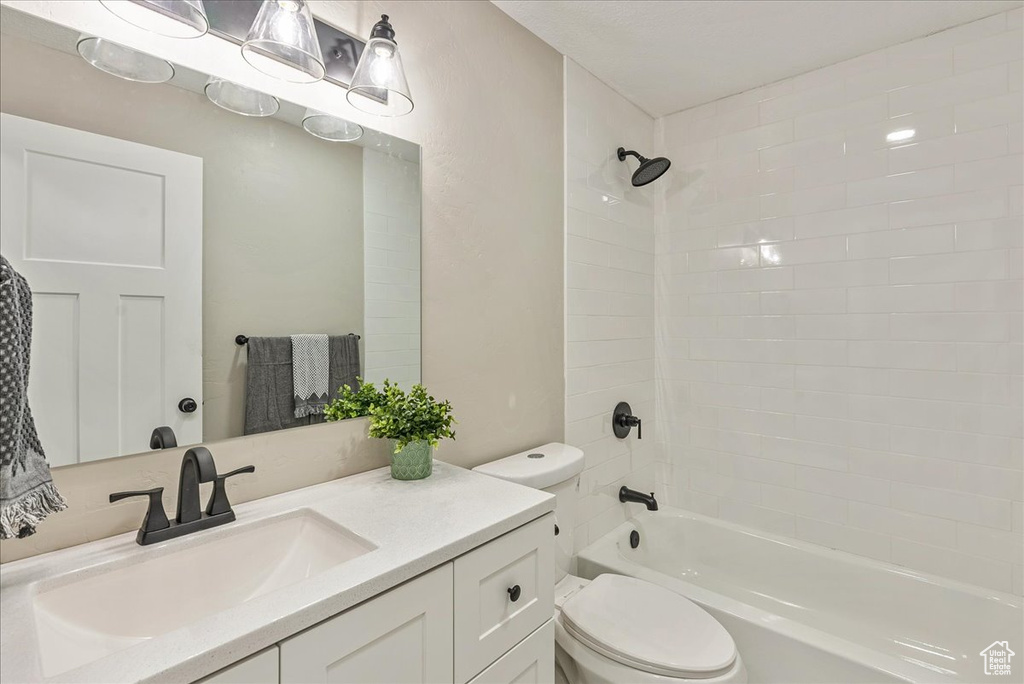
[{"left": 0, "top": 6, "right": 420, "bottom": 466}]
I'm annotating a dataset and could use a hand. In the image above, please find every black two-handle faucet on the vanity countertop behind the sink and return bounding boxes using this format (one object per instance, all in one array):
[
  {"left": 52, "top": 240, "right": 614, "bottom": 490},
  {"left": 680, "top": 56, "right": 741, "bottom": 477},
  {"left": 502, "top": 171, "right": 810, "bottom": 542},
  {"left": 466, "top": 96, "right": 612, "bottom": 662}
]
[{"left": 111, "top": 446, "right": 256, "bottom": 546}]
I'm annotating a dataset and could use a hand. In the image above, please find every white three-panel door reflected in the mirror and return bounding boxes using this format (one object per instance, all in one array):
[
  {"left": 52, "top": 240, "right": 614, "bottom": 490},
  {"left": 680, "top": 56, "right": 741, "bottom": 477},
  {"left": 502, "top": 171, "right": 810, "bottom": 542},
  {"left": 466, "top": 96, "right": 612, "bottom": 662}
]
[{"left": 0, "top": 114, "right": 203, "bottom": 466}]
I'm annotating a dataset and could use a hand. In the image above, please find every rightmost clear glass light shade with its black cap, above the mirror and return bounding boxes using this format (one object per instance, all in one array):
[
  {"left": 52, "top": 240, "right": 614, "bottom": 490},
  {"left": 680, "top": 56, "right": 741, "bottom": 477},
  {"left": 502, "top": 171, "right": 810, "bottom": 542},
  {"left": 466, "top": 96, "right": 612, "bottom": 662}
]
[{"left": 346, "top": 14, "right": 413, "bottom": 117}]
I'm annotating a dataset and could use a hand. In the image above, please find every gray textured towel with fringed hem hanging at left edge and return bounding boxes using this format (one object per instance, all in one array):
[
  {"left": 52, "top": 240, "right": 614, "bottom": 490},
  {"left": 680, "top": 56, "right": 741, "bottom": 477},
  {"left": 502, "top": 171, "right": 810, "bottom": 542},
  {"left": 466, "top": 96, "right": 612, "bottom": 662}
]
[{"left": 0, "top": 256, "right": 68, "bottom": 539}]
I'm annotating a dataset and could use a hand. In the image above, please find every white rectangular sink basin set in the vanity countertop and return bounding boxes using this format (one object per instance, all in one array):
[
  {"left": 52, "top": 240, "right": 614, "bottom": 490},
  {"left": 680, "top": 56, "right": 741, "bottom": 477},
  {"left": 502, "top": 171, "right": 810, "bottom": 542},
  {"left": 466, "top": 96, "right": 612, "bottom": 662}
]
[{"left": 33, "top": 511, "right": 376, "bottom": 677}]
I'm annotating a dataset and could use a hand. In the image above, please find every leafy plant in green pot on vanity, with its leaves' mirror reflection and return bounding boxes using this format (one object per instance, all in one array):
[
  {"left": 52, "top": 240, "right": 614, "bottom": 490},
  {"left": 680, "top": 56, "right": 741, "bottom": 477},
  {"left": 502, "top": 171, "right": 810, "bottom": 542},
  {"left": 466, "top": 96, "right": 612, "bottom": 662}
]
[{"left": 324, "top": 379, "right": 455, "bottom": 480}]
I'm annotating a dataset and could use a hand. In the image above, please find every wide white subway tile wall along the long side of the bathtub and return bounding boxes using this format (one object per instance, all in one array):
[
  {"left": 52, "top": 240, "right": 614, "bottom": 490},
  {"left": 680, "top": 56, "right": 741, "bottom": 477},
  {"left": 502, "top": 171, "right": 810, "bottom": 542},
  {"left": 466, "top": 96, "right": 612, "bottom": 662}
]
[{"left": 655, "top": 9, "right": 1024, "bottom": 594}]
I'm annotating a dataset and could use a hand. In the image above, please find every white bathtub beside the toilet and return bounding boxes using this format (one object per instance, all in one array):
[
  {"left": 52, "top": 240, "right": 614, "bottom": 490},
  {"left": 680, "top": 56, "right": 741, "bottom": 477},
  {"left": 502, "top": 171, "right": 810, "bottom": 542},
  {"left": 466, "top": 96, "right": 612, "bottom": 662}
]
[{"left": 579, "top": 508, "right": 1024, "bottom": 684}]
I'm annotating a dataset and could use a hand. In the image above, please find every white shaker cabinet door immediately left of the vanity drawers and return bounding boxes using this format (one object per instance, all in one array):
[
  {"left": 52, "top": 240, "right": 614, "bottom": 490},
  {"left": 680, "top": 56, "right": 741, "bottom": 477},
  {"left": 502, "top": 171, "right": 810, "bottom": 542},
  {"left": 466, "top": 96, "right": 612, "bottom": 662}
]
[{"left": 281, "top": 563, "right": 454, "bottom": 684}]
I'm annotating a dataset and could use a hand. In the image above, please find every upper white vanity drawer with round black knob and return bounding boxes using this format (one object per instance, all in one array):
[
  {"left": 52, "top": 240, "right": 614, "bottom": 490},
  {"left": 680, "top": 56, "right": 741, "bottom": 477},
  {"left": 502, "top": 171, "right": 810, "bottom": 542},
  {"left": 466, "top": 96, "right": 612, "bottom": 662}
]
[{"left": 455, "top": 514, "right": 555, "bottom": 682}]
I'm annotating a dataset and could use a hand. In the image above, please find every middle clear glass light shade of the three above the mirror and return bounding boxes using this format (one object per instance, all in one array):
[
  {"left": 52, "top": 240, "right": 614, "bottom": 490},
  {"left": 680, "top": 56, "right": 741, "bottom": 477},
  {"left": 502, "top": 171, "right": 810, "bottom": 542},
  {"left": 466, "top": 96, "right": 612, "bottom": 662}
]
[{"left": 242, "top": 0, "right": 327, "bottom": 83}]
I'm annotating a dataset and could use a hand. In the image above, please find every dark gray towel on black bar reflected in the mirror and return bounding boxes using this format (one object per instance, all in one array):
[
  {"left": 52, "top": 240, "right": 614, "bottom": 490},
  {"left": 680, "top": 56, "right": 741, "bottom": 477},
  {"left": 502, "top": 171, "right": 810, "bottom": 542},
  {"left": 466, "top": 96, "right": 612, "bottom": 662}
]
[{"left": 245, "top": 335, "right": 359, "bottom": 434}]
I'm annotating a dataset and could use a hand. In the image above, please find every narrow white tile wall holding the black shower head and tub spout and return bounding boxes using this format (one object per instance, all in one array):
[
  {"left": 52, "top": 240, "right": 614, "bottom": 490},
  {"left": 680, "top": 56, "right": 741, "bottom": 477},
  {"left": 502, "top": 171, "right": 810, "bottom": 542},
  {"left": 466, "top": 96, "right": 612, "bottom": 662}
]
[{"left": 565, "top": 58, "right": 667, "bottom": 550}]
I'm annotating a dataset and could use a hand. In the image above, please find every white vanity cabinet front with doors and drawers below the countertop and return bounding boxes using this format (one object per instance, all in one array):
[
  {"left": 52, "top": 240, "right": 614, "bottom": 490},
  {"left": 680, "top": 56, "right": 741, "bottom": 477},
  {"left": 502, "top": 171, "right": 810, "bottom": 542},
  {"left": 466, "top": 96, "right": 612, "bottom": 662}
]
[{"left": 222, "top": 513, "right": 555, "bottom": 684}]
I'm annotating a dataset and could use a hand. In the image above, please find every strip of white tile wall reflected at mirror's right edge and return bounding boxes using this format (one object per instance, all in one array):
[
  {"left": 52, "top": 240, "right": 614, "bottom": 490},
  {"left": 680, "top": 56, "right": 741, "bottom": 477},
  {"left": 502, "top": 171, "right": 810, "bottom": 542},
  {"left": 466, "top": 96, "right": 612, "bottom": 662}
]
[{"left": 362, "top": 147, "right": 420, "bottom": 389}]
